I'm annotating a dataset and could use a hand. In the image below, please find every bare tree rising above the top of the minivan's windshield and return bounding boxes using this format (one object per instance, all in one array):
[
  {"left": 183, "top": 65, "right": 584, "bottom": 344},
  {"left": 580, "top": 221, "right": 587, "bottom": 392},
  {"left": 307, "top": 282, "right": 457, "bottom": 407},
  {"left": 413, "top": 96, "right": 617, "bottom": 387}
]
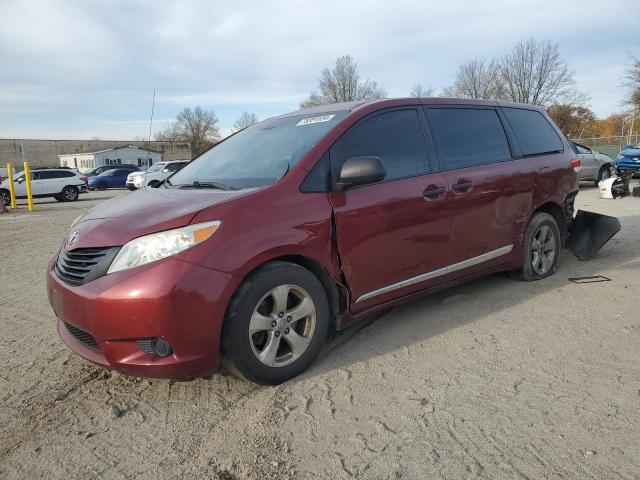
[{"left": 300, "top": 55, "right": 387, "bottom": 108}]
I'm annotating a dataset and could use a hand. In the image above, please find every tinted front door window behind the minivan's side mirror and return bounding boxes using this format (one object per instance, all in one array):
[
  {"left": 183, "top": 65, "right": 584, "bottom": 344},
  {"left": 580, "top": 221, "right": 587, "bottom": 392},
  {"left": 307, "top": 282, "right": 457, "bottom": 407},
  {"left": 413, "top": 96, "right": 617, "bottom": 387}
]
[{"left": 331, "top": 109, "right": 428, "bottom": 180}]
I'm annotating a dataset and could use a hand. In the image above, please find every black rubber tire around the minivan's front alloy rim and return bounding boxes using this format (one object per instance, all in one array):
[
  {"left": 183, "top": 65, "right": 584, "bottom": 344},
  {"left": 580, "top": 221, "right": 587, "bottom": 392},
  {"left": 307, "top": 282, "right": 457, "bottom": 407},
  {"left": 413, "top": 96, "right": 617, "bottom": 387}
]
[{"left": 221, "top": 261, "right": 330, "bottom": 385}]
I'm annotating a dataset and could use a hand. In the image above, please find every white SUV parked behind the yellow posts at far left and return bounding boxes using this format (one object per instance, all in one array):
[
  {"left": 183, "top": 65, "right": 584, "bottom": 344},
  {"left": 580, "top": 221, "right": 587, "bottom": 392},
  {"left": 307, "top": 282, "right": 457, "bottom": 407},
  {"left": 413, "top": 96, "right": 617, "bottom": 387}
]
[{"left": 0, "top": 168, "right": 88, "bottom": 205}]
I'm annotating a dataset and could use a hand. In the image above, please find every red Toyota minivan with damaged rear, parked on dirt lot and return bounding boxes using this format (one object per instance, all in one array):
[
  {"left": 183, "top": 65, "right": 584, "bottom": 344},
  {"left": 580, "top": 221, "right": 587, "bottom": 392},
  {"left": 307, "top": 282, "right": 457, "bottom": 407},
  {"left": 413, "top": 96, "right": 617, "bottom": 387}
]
[{"left": 47, "top": 98, "right": 580, "bottom": 384}]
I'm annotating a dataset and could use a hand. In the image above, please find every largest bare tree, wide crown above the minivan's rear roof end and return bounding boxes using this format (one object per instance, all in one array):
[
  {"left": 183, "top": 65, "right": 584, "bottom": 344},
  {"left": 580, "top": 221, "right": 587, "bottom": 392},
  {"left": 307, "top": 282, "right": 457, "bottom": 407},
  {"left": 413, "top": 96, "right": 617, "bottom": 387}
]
[{"left": 496, "top": 38, "right": 585, "bottom": 106}]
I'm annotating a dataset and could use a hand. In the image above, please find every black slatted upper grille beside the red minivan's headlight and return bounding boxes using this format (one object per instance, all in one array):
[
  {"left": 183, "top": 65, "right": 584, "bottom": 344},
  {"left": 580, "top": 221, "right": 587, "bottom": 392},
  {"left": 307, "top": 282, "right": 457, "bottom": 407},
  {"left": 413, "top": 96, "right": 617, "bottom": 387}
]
[{"left": 55, "top": 247, "right": 119, "bottom": 285}]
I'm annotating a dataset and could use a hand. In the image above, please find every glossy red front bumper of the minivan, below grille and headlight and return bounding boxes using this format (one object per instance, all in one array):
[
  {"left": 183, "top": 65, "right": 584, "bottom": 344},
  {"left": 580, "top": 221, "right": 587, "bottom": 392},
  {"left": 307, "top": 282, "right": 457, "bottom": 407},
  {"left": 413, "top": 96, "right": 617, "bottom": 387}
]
[{"left": 47, "top": 258, "right": 239, "bottom": 378}]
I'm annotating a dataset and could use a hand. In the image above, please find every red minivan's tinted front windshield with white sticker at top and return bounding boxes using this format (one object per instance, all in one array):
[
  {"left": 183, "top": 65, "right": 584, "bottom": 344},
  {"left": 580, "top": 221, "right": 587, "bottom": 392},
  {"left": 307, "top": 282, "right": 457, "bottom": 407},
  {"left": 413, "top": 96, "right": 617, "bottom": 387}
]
[{"left": 171, "top": 111, "right": 347, "bottom": 188}]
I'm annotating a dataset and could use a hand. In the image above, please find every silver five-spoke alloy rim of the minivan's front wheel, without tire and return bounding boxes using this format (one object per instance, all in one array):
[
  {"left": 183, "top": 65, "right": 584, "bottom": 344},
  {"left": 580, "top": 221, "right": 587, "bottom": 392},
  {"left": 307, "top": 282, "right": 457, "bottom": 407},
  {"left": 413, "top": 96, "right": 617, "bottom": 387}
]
[{"left": 249, "top": 285, "right": 316, "bottom": 367}]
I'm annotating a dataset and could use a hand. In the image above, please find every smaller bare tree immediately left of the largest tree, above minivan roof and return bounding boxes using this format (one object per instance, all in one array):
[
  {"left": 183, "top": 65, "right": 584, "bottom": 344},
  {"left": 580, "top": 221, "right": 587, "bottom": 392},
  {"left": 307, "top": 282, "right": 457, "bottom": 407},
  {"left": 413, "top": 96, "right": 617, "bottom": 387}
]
[{"left": 444, "top": 58, "right": 499, "bottom": 100}]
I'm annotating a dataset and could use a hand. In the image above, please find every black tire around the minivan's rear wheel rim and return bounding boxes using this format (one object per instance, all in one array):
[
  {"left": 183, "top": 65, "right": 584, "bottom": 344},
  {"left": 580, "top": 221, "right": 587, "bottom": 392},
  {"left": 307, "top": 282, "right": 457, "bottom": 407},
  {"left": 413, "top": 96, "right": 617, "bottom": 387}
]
[{"left": 514, "top": 212, "right": 562, "bottom": 282}]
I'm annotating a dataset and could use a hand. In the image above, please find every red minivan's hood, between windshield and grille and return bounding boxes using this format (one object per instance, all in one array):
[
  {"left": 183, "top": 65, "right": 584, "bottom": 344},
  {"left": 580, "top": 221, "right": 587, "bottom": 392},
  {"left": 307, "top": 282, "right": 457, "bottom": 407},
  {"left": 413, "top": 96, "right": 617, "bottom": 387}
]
[{"left": 65, "top": 188, "right": 252, "bottom": 249}]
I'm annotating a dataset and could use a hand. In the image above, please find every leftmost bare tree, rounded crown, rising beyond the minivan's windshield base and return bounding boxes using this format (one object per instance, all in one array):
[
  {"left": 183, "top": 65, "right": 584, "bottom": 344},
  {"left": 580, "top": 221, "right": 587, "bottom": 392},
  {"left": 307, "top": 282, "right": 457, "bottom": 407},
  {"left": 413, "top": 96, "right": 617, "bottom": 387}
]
[{"left": 155, "top": 106, "right": 220, "bottom": 155}]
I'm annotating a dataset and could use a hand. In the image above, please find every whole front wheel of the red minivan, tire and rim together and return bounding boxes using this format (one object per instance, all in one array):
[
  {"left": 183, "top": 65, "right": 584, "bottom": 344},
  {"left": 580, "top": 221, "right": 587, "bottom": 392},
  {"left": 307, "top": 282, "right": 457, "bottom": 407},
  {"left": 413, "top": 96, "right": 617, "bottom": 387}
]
[{"left": 222, "top": 262, "right": 330, "bottom": 385}]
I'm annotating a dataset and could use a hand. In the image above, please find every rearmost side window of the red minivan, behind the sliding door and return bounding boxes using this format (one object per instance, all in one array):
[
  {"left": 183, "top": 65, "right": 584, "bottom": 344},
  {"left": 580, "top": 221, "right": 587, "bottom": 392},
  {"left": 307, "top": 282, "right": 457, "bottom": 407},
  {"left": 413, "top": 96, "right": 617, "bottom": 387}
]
[{"left": 502, "top": 108, "right": 564, "bottom": 155}]
